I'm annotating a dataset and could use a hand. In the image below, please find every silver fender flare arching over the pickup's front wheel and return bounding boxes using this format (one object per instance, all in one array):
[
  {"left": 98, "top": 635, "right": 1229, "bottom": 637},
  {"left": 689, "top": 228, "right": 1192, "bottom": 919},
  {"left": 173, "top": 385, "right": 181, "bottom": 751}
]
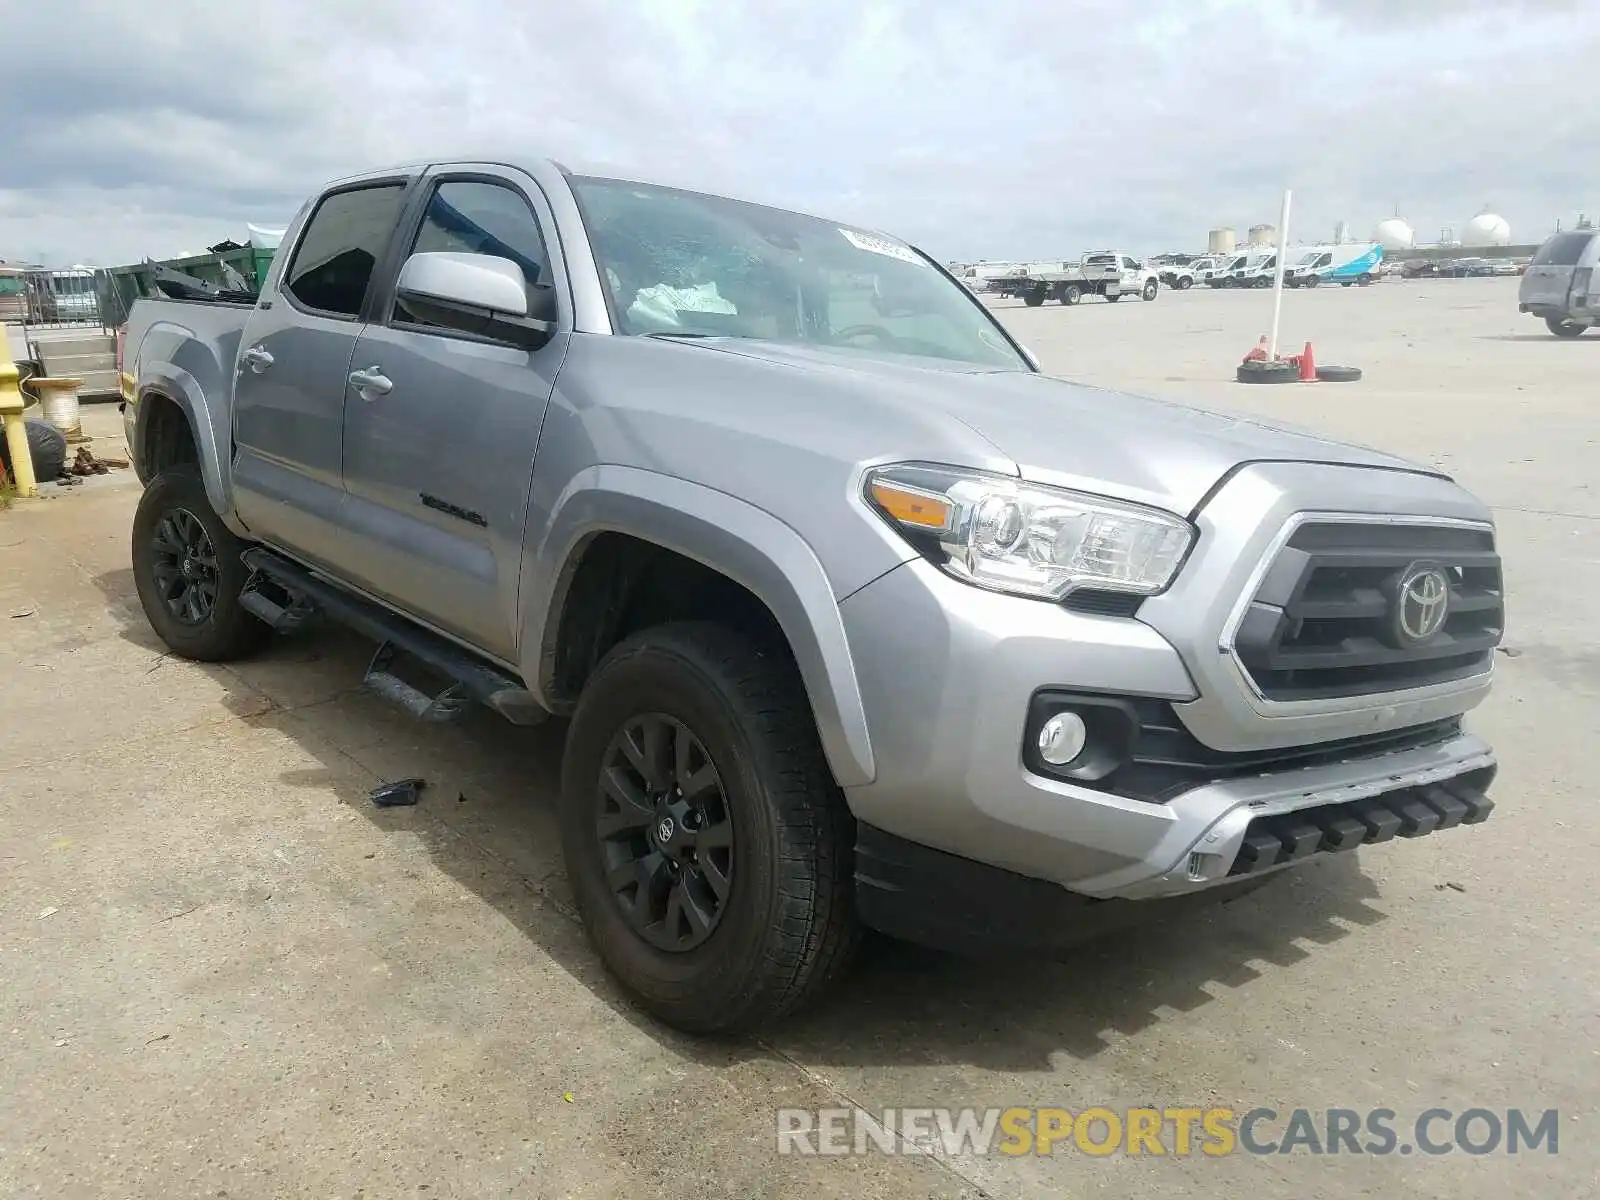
[{"left": 518, "top": 466, "right": 877, "bottom": 787}]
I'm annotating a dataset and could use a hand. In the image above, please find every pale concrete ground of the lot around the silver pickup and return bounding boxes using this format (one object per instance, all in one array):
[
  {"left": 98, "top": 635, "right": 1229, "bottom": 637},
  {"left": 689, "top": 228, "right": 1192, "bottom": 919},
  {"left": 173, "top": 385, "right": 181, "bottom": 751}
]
[{"left": 0, "top": 280, "right": 1600, "bottom": 1200}]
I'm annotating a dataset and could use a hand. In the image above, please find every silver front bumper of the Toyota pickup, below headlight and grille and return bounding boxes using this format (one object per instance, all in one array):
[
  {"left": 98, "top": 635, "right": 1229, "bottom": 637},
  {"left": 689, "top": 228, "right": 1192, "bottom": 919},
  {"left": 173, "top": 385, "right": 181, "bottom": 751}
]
[{"left": 842, "top": 521, "right": 1496, "bottom": 899}]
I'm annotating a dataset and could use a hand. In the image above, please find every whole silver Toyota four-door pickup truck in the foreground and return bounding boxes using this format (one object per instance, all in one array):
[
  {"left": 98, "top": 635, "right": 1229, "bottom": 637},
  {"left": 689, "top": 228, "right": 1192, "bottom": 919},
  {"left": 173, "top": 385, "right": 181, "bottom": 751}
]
[{"left": 123, "top": 162, "right": 1502, "bottom": 1030}]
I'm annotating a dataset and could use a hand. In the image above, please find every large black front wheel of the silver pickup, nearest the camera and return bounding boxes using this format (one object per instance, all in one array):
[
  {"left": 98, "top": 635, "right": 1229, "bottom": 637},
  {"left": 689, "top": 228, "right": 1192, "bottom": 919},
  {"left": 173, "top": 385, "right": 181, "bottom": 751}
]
[{"left": 562, "top": 622, "right": 858, "bottom": 1034}]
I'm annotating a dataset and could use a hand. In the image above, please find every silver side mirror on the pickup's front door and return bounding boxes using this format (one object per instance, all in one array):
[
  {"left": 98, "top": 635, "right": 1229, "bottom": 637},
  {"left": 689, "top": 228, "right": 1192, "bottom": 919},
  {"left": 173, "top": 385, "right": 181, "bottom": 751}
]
[{"left": 395, "top": 251, "right": 557, "bottom": 350}]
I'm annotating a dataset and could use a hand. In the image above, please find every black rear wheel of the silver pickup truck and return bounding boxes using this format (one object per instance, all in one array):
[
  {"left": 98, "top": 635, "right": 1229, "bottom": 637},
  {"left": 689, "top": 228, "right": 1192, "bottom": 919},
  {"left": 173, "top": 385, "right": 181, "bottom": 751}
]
[{"left": 131, "top": 466, "right": 272, "bottom": 662}]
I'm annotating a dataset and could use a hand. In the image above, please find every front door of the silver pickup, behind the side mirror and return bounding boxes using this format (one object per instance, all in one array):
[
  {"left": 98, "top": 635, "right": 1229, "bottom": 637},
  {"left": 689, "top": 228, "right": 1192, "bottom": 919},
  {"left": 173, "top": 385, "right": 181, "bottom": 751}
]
[{"left": 342, "top": 166, "right": 571, "bottom": 661}]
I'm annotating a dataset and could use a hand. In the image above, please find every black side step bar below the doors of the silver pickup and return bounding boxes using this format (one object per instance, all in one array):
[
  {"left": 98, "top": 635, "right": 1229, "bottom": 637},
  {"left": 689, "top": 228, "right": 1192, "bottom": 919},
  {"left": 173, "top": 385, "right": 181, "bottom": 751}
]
[{"left": 242, "top": 546, "right": 550, "bottom": 725}]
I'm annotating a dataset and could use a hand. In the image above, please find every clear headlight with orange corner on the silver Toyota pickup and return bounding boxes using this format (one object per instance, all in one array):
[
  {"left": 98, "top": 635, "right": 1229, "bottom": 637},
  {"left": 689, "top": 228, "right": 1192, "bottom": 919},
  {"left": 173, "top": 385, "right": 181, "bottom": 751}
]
[{"left": 866, "top": 466, "right": 1194, "bottom": 600}]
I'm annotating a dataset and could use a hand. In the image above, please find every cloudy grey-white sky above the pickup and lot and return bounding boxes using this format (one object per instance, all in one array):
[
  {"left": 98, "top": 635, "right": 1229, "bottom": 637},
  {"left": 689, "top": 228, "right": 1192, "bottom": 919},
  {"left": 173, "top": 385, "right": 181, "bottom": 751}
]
[{"left": 0, "top": 0, "right": 1600, "bottom": 264}]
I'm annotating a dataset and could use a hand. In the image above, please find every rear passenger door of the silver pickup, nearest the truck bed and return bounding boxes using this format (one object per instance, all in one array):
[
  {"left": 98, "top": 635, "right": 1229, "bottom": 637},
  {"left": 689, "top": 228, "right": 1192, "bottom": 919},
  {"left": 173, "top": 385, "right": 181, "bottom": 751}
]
[{"left": 234, "top": 178, "right": 408, "bottom": 565}]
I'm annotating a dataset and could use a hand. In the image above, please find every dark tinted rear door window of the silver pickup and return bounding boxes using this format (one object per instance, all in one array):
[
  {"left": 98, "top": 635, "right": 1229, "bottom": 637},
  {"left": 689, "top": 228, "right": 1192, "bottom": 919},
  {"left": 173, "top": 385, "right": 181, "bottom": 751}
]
[{"left": 283, "top": 184, "right": 405, "bottom": 317}]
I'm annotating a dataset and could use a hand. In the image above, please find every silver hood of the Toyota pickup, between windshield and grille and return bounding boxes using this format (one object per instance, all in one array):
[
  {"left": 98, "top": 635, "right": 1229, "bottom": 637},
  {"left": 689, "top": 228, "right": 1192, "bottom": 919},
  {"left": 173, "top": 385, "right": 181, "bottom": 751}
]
[{"left": 680, "top": 339, "right": 1438, "bottom": 515}]
